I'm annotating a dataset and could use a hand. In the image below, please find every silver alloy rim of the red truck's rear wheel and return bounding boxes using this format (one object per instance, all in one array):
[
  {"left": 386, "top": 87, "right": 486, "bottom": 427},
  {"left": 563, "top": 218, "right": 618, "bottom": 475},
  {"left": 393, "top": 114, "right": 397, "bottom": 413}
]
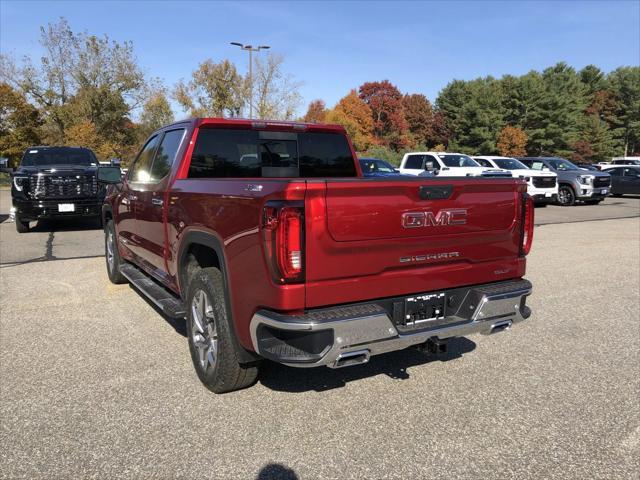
[{"left": 191, "top": 290, "right": 218, "bottom": 371}]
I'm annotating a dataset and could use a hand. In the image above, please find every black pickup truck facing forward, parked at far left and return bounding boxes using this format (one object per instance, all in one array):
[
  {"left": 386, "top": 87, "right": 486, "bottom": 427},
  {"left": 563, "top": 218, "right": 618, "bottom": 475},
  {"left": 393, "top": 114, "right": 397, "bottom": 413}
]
[{"left": 11, "top": 147, "right": 105, "bottom": 233}]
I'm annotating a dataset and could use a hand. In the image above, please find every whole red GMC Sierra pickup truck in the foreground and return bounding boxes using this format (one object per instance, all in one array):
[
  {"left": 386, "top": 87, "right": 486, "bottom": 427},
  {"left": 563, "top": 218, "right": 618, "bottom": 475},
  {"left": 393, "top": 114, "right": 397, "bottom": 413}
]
[{"left": 101, "top": 118, "right": 533, "bottom": 393}]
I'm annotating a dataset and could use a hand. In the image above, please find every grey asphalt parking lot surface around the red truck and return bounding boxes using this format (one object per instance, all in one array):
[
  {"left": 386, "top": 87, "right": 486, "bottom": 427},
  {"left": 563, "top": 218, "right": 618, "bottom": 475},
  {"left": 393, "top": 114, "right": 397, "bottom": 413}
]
[{"left": 0, "top": 191, "right": 640, "bottom": 479}]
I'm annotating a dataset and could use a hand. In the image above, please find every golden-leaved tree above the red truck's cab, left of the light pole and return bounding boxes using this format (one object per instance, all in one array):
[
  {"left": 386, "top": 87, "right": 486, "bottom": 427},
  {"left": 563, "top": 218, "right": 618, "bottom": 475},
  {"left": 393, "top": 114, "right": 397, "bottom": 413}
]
[{"left": 173, "top": 58, "right": 247, "bottom": 117}]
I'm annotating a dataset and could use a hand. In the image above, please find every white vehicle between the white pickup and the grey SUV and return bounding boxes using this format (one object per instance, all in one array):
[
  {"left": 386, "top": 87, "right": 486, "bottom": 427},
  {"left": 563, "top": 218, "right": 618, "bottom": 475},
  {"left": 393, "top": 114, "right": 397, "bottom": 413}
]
[{"left": 473, "top": 155, "right": 558, "bottom": 204}]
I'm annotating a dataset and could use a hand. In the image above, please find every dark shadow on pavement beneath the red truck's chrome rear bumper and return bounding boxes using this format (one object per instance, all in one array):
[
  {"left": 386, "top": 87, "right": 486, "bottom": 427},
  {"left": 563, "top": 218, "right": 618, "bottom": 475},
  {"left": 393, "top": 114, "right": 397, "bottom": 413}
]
[{"left": 259, "top": 337, "right": 476, "bottom": 392}]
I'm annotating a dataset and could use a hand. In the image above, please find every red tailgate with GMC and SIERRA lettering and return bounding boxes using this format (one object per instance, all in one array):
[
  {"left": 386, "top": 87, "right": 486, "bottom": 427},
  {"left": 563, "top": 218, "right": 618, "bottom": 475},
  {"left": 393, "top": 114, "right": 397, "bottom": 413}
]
[{"left": 305, "top": 178, "right": 526, "bottom": 307}]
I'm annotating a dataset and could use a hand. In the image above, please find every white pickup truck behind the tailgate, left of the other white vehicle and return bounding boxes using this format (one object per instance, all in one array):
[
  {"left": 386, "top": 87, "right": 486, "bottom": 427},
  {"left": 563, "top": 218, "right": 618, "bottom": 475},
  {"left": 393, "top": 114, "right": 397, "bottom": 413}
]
[{"left": 400, "top": 152, "right": 508, "bottom": 177}]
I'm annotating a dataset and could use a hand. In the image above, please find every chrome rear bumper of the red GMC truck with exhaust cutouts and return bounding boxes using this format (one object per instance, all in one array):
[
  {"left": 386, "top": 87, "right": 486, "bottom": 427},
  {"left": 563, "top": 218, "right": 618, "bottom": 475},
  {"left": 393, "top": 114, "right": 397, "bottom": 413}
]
[{"left": 250, "top": 280, "right": 532, "bottom": 368}]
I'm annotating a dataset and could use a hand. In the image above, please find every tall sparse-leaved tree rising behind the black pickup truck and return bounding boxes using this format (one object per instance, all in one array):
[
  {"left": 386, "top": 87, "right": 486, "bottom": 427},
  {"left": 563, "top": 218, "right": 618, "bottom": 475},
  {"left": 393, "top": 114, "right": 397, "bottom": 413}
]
[{"left": 2, "top": 19, "right": 145, "bottom": 158}]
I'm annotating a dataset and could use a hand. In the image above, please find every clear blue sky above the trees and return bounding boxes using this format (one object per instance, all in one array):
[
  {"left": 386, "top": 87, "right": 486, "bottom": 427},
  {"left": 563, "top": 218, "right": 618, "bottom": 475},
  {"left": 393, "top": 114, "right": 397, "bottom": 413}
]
[{"left": 0, "top": 0, "right": 640, "bottom": 115}]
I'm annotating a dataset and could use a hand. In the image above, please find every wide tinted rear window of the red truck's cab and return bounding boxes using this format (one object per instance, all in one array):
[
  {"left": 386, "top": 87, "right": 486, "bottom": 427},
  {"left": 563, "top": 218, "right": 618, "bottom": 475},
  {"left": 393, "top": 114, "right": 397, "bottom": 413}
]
[{"left": 189, "top": 128, "right": 356, "bottom": 178}]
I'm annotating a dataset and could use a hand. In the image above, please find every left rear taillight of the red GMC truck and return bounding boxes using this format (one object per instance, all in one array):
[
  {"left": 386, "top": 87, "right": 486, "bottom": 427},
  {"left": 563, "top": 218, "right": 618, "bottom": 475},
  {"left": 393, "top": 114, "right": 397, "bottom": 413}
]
[{"left": 262, "top": 202, "right": 304, "bottom": 283}]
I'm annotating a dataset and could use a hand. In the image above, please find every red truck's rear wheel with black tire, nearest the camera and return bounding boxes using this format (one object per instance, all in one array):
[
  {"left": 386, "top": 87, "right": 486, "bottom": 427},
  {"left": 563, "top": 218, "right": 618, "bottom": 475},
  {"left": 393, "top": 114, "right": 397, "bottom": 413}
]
[{"left": 186, "top": 267, "right": 258, "bottom": 393}]
